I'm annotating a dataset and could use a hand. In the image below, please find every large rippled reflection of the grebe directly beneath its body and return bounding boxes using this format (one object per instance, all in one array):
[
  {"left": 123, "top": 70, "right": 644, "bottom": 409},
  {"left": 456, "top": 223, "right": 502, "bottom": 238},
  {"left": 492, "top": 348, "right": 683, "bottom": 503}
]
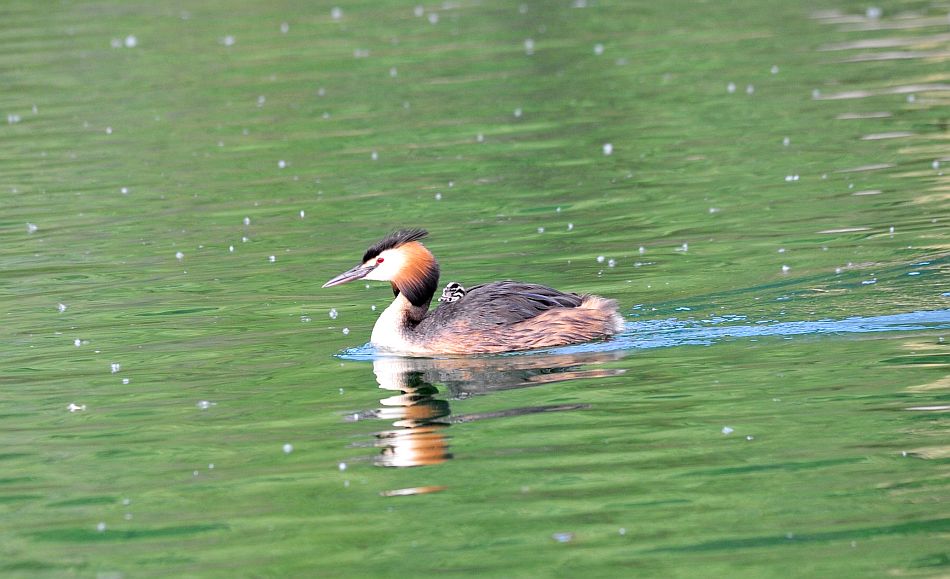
[{"left": 358, "top": 352, "right": 623, "bottom": 472}]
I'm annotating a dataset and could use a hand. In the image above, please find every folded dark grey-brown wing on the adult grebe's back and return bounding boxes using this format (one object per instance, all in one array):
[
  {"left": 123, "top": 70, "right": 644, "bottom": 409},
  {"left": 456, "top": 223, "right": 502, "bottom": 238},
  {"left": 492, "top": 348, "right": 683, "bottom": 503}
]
[{"left": 426, "top": 281, "right": 584, "bottom": 327}]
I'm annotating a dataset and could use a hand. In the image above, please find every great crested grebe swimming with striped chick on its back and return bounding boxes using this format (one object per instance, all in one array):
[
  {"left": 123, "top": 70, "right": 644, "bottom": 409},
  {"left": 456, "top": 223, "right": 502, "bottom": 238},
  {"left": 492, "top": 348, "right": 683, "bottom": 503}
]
[{"left": 323, "top": 229, "right": 623, "bottom": 355}]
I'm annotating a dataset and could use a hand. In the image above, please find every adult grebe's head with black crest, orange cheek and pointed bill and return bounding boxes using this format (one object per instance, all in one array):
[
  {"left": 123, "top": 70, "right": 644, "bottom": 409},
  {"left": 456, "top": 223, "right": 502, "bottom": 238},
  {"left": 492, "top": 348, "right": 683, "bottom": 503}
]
[{"left": 323, "top": 229, "right": 439, "bottom": 306}]
